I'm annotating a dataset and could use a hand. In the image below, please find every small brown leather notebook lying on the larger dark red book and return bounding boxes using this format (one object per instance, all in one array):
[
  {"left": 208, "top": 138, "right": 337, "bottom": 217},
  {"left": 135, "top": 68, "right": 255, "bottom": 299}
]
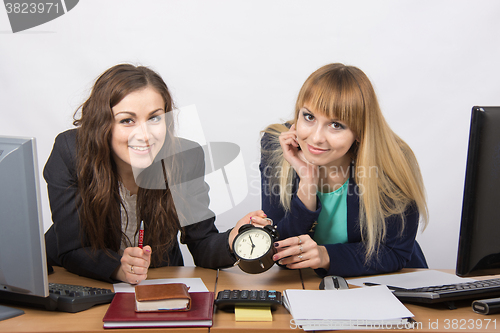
[{"left": 135, "top": 283, "right": 191, "bottom": 312}]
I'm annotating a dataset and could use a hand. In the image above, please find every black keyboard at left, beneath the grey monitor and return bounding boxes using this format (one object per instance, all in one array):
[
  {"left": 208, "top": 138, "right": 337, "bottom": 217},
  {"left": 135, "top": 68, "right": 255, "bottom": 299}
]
[{"left": 0, "top": 283, "right": 115, "bottom": 313}]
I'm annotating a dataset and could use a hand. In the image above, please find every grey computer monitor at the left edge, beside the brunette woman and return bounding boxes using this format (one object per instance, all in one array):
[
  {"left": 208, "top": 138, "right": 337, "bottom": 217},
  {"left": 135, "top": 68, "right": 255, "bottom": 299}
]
[{"left": 0, "top": 136, "right": 49, "bottom": 316}]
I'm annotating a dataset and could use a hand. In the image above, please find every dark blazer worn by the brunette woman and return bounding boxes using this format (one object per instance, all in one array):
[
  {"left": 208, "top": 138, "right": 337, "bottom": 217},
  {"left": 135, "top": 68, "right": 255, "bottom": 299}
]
[{"left": 43, "top": 129, "right": 236, "bottom": 282}]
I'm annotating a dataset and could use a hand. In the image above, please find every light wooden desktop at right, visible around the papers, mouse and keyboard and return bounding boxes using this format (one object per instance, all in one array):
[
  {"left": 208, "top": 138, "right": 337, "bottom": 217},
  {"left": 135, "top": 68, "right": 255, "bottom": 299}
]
[{"left": 301, "top": 269, "right": 500, "bottom": 333}]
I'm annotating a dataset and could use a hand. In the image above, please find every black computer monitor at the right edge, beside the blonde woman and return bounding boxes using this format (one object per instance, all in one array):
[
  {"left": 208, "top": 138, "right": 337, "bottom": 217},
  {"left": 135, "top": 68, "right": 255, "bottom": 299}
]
[{"left": 456, "top": 106, "right": 500, "bottom": 276}]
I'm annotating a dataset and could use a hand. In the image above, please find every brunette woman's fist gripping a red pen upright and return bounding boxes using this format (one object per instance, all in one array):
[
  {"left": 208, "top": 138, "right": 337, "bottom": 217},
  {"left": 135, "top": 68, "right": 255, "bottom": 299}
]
[{"left": 113, "top": 245, "right": 151, "bottom": 284}]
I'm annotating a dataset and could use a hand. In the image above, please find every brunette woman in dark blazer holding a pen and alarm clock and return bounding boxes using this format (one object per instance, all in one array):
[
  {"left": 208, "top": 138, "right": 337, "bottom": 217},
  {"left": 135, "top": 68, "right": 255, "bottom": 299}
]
[{"left": 43, "top": 64, "right": 268, "bottom": 284}]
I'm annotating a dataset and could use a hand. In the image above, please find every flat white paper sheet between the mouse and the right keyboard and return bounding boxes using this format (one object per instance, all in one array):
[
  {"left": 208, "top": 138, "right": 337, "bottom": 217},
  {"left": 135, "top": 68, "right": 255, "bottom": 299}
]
[{"left": 347, "top": 269, "right": 475, "bottom": 289}]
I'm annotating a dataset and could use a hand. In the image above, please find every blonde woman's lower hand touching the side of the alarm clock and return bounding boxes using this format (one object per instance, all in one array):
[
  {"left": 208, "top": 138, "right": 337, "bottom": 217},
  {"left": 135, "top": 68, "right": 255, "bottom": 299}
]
[{"left": 273, "top": 235, "right": 330, "bottom": 270}]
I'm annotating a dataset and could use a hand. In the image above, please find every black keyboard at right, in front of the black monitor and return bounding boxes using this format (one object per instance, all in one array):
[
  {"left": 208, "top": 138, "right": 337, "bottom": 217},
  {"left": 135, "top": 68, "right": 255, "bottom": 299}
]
[{"left": 389, "top": 278, "right": 500, "bottom": 303}]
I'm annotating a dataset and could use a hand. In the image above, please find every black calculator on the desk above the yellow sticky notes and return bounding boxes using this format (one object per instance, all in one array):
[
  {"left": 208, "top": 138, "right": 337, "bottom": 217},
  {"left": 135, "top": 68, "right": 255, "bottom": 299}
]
[{"left": 214, "top": 290, "right": 282, "bottom": 312}]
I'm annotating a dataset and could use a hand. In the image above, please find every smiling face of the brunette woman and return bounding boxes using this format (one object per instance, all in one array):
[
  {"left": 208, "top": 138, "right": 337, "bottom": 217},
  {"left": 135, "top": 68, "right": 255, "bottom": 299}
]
[{"left": 111, "top": 86, "right": 166, "bottom": 176}]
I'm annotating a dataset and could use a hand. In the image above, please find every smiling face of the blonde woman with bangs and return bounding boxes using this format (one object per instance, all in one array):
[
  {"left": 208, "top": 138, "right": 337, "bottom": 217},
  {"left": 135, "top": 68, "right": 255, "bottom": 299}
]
[{"left": 296, "top": 104, "right": 356, "bottom": 168}]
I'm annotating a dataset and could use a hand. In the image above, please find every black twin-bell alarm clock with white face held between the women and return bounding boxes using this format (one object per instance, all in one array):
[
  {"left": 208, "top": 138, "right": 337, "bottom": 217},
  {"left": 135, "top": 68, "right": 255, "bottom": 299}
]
[{"left": 233, "top": 224, "right": 278, "bottom": 274}]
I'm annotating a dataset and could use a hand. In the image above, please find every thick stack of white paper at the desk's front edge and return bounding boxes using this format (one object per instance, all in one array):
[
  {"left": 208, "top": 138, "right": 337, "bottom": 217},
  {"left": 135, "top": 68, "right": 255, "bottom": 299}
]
[{"left": 284, "top": 286, "right": 413, "bottom": 331}]
